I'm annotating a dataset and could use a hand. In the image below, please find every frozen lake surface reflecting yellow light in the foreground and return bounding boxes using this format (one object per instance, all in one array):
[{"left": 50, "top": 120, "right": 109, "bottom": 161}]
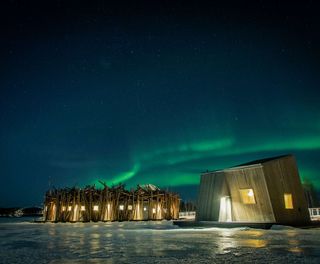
[{"left": 0, "top": 219, "right": 320, "bottom": 263}]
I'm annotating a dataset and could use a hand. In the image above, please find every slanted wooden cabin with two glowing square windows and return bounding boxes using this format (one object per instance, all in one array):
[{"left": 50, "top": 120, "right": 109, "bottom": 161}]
[{"left": 196, "top": 155, "right": 310, "bottom": 225}]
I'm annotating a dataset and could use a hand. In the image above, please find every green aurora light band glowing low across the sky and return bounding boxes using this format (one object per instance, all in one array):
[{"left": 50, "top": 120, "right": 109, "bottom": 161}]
[{"left": 95, "top": 136, "right": 320, "bottom": 187}]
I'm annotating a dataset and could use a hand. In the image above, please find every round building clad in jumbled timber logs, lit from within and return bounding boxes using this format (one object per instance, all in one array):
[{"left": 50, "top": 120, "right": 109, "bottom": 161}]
[{"left": 43, "top": 183, "right": 180, "bottom": 222}]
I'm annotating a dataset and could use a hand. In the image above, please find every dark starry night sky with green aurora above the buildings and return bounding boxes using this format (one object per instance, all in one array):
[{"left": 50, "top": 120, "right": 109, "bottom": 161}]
[{"left": 0, "top": 0, "right": 320, "bottom": 206}]
